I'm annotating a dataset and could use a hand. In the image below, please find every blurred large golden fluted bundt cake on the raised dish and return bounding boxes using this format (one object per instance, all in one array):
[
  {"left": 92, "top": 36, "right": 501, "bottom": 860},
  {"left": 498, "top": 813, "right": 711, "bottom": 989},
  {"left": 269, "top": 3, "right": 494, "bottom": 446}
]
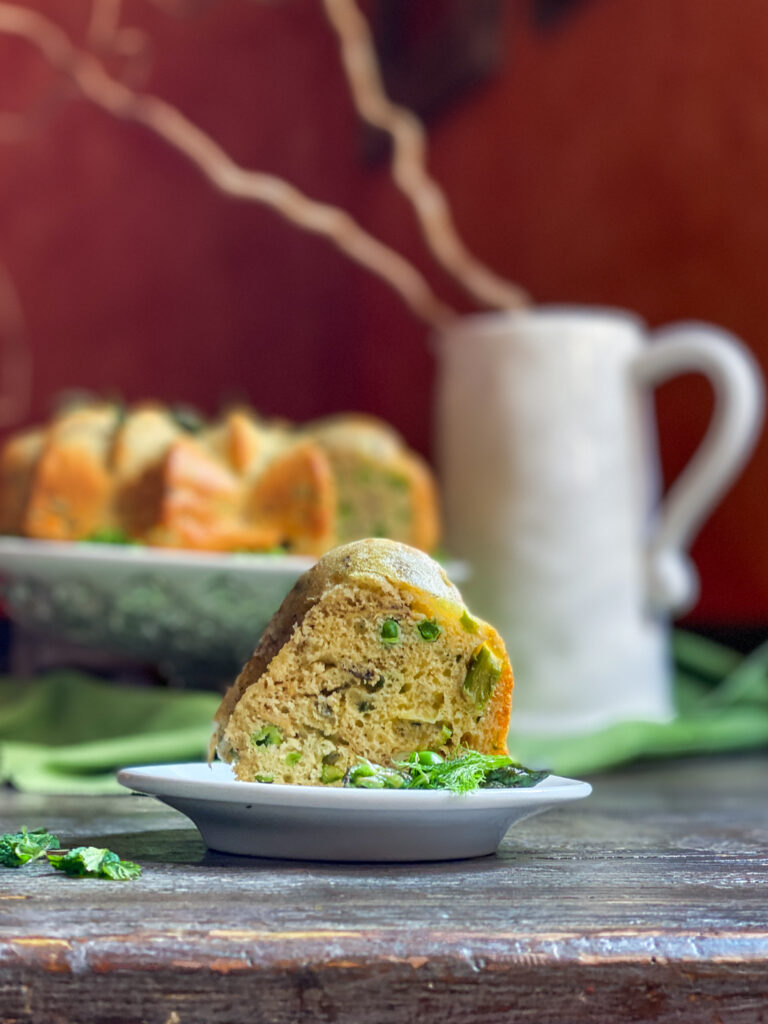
[{"left": 0, "top": 402, "right": 440, "bottom": 555}]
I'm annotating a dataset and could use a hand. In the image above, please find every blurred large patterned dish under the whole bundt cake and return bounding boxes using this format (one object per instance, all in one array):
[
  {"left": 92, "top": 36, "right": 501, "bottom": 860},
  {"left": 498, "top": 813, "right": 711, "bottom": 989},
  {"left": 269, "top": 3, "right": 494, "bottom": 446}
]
[{"left": 0, "top": 537, "right": 467, "bottom": 684}]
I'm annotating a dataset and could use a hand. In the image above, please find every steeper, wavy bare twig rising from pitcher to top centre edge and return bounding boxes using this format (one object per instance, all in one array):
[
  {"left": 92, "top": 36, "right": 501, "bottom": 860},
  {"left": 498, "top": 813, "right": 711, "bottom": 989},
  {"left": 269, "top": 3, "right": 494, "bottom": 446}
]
[{"left": 323, "top": 0, "right": 528, "bottom": 308}]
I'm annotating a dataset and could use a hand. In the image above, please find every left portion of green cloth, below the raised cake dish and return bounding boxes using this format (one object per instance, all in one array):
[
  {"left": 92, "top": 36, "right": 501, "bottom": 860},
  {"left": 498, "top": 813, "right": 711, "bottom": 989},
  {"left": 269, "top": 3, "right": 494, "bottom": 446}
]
[{"left": 0, "top": 672, "right": 221, "bottom": 794}]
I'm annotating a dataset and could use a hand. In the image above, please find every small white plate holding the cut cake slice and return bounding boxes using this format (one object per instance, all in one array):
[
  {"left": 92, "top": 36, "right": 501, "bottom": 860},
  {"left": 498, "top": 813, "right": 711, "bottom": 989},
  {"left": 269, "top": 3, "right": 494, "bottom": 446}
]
[{"left": 118, "top": 762, "right": 592, "bottom": 861}]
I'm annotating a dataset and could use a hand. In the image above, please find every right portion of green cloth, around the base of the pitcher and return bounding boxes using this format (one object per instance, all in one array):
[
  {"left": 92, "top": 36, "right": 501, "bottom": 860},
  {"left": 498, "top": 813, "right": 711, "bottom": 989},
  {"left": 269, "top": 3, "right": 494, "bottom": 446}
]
[{"left": 510, "top": 630, "right": 768, "bottom": 776}]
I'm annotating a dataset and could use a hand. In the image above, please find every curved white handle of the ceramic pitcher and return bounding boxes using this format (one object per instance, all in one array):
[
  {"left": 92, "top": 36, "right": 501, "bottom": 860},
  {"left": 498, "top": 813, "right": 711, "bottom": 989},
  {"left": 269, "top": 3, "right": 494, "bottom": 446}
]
[{"left": 634, "top": 322, "right": 763, "bottom": 612}]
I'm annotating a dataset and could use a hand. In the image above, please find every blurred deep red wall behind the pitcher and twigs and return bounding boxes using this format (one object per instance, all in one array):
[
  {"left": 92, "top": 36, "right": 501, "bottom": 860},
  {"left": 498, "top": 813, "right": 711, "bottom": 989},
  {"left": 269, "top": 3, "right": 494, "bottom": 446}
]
[{"left": 0, "top": 0, "right": 768, "bottom": 622}]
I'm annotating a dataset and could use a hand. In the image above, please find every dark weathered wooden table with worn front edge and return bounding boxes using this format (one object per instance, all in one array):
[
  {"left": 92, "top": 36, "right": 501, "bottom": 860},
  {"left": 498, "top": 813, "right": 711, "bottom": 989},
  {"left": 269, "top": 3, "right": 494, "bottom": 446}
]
[{"left": 0, "top": 757, "right": 768, "bottom": 1024}]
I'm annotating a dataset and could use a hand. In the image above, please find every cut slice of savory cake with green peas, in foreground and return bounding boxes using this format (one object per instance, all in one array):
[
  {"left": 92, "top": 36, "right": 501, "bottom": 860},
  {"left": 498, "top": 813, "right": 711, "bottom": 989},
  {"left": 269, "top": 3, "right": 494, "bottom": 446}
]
[{"left": 212, "top": 539, "right": 513, "bottom": 785}]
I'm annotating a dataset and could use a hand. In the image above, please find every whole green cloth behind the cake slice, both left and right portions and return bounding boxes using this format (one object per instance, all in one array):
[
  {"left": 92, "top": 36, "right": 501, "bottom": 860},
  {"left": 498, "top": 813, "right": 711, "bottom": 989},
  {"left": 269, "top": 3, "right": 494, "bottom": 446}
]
[{"left": 0, "top": 632, "right": 768, "bottom": 794}]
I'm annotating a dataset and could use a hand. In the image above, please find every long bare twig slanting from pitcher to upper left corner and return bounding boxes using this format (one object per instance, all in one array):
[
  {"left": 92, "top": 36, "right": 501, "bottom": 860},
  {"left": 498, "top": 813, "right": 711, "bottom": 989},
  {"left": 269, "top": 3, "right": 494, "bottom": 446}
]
[{"left": 0, "top": 2, "right": 455, "bottom": 327}]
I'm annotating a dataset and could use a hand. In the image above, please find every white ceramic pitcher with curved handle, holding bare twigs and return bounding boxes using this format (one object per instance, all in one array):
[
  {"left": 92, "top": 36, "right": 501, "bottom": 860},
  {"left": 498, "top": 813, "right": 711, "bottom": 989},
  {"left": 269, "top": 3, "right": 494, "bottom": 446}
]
[{"left": 436, "top": 307, "right": 762, "bottom": 733}]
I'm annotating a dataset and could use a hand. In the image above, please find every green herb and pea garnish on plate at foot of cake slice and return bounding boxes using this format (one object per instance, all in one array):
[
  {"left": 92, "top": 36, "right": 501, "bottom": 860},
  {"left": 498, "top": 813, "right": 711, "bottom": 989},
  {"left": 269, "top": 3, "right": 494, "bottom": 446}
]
[{"left": 395, "top": 751, "right": 549, "bottom": 793}]
